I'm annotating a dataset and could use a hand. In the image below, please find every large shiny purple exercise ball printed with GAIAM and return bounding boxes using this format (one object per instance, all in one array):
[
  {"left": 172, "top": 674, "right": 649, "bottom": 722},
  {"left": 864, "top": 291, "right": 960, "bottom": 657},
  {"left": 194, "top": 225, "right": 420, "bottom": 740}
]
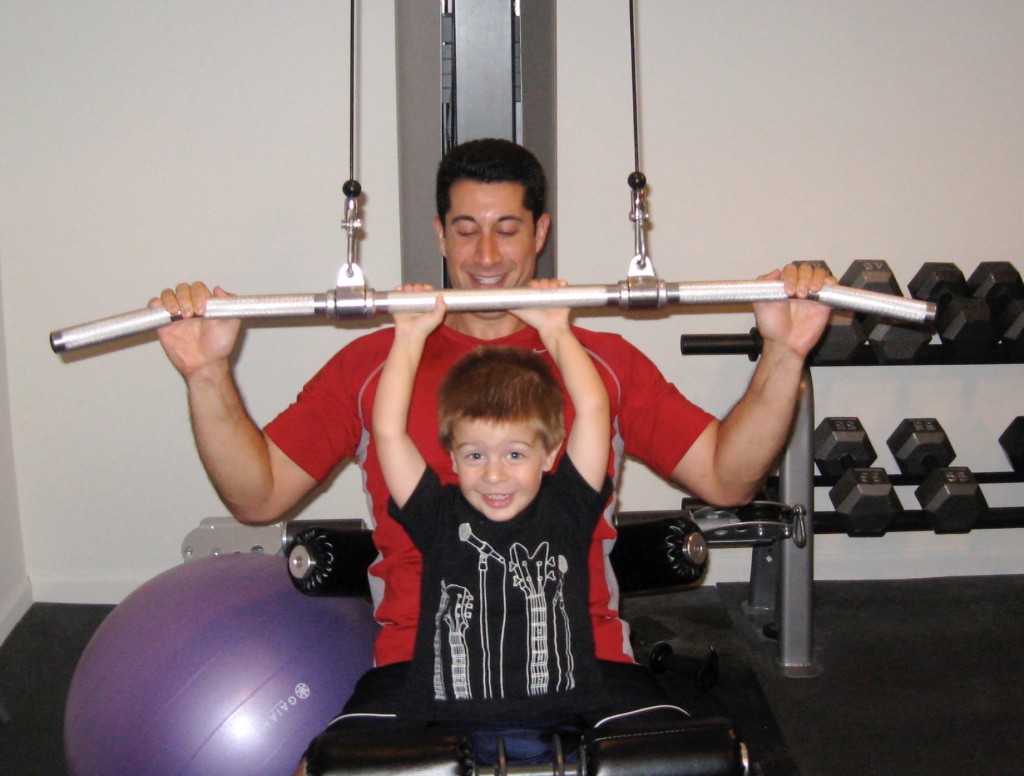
[{"left": 65, "top": 554, "right": 377, "bottom": 776}]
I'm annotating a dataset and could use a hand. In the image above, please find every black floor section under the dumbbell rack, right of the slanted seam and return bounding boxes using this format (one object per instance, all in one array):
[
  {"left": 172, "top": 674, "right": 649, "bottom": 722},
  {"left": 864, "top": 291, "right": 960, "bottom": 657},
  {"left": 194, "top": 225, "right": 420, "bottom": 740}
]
[{"left": 719, "top": 575, "right": 1024, "bottom": 776}]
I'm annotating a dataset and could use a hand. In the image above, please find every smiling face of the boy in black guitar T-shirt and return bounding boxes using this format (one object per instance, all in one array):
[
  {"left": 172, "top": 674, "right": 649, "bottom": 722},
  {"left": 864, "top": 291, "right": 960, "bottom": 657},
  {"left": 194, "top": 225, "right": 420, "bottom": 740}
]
[{"left": 452, "top": 421, "right": 558, "bottom": 521}]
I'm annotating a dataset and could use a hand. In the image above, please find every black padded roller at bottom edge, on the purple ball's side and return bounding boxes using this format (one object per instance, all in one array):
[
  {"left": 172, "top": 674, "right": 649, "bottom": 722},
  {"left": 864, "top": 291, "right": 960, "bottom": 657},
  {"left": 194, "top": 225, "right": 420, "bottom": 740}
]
[{"left": 306, "top": 727, "right": 474, "bottom": 776}]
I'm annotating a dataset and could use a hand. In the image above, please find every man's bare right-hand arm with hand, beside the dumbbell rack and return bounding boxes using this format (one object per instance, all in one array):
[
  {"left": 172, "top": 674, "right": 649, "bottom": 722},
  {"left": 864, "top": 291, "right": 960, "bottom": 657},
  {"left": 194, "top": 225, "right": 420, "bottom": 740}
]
[{"left": 672, "top": 264, "right": 835, "bottom": 506}]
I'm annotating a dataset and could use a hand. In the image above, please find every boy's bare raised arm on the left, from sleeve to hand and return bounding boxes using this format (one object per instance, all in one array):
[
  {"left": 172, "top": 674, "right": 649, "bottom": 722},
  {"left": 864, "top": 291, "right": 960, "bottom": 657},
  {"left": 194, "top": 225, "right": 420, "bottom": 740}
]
[{"left": 373, "top": 286, "right": 444, "bottom": 508}]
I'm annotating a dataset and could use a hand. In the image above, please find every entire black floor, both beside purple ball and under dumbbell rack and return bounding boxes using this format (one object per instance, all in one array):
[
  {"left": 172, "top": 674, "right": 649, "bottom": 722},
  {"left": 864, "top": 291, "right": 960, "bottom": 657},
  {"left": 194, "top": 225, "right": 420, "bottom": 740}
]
[{"left": 0, "top": 576, "right": 1024, "bottom": 776}]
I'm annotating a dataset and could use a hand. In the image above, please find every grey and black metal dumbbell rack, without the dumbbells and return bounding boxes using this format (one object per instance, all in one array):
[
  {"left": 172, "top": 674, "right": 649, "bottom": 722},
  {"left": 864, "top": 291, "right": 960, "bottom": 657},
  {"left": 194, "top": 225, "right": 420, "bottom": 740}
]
[{"left": 680, "top": 329, "right": 1024, "bottom": 678}]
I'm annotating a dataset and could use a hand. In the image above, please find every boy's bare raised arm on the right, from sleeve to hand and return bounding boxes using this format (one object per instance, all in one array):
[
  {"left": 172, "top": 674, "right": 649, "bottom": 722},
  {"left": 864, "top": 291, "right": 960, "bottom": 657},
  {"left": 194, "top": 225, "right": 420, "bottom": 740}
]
[{"left": 513, "top": 281, "right": 611, "bottom": 490}]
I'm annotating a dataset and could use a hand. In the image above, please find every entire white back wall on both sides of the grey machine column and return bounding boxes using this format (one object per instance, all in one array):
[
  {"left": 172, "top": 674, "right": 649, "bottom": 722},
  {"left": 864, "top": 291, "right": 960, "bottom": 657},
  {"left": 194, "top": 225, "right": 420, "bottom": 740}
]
[{"left": 0, "top": 0, "right": 1024, "bottom": 601}]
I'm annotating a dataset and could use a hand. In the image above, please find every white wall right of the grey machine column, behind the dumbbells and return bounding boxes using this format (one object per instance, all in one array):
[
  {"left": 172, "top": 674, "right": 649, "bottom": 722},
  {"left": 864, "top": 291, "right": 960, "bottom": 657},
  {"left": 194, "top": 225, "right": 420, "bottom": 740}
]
[{"left": 558, "top": 0, "right": 1024, "bottom": 578}]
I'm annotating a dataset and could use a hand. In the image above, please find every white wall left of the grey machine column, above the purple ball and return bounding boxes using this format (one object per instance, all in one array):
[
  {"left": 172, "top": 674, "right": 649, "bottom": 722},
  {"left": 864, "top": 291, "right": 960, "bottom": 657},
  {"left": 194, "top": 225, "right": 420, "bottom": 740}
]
[{"left": 0, "top": 0, "right": 399, "bottom": 601}]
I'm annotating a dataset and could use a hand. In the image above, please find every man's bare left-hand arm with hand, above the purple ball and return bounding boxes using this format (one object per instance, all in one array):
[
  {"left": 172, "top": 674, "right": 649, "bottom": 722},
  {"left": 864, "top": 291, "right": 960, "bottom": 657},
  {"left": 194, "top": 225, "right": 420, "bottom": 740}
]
[{"left": 151, "top": 283, "right": 316, "bottom": 525}]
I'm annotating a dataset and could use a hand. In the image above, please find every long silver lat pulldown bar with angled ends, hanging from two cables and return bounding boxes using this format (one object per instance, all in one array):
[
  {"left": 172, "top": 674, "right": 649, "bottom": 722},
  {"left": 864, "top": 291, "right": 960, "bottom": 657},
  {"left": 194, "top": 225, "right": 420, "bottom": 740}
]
[{"left": 50, "top": 276, "right": 935, "bottom": 353}]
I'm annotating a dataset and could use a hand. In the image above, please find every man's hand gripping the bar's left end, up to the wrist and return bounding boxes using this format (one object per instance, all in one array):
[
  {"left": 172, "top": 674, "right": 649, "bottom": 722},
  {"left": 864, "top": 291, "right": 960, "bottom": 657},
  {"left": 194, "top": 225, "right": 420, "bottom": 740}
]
[{"left": 150, "top": 283, "right": 242, "bottom": 380}]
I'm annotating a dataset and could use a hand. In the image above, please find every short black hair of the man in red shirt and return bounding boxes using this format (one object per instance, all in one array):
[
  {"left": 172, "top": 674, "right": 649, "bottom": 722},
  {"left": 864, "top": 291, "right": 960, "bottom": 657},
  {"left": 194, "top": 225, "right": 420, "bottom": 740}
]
[{"left": 436, "top": 137, "right": 548, "bottom": 224}]
